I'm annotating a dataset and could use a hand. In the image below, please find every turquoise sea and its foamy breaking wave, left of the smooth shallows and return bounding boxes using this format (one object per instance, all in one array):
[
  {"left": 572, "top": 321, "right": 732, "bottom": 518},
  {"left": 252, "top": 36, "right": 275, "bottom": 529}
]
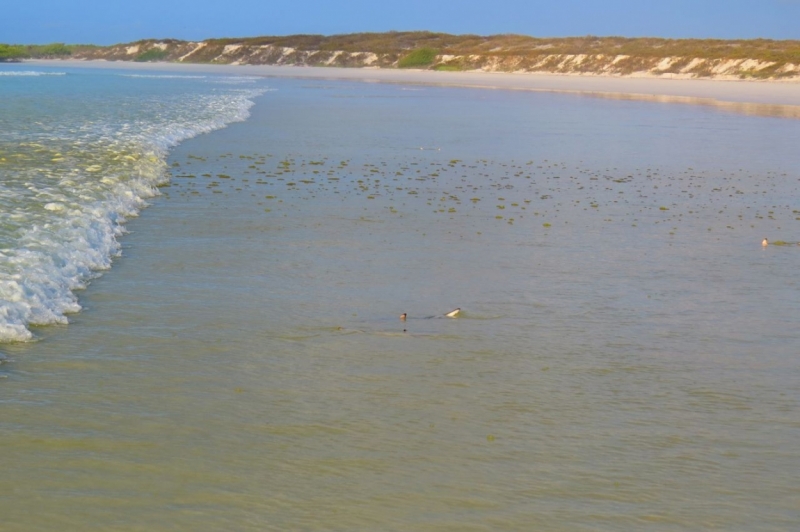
[{"left": 0, "top": 66, "right": 259, "bottom": 342}]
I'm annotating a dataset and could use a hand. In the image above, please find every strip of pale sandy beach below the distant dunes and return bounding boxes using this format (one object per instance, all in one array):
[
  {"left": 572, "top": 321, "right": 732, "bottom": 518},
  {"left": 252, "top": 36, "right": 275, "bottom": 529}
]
[{"left": 22, "top": 60, "right": 800, "bottom": 119}]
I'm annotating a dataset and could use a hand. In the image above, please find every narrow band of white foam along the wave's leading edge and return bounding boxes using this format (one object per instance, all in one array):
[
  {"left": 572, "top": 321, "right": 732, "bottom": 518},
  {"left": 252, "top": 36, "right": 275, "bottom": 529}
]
[{"left": 0, "top": 85, "right": 266, "bottom": 342}]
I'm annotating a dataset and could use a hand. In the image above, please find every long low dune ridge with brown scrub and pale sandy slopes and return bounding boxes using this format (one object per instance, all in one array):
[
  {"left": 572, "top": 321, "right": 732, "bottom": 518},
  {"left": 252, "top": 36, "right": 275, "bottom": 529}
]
[{"left": 10, "top": 32, "right": 800, "bottom": 80}]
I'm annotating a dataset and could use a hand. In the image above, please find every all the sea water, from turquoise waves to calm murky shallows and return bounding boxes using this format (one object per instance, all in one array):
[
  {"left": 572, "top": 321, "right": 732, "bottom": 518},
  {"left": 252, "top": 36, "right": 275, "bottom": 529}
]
[{"left": 0, "top": 66, "right": 800, "bottom": 531}]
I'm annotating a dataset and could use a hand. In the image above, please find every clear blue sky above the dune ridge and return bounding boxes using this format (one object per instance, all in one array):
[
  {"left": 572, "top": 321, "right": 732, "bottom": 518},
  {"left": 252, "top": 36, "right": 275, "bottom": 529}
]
[{"left": 6, "top": 0, "right": 800, "bottom": 44}]
